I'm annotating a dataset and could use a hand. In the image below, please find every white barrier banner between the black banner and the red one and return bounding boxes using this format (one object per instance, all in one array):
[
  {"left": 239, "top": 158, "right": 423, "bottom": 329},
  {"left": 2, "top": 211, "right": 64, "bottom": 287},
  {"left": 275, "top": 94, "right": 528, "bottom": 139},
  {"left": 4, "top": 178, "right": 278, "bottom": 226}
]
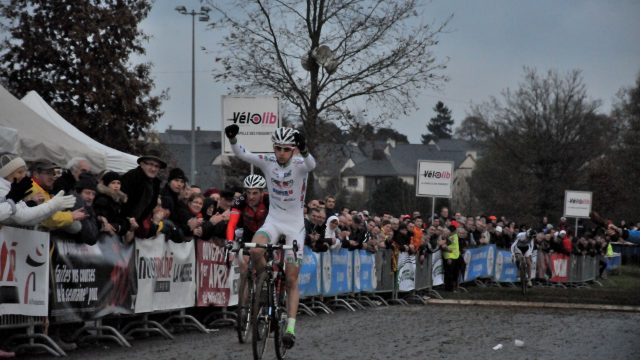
[{"left": 135, "top": 234, "right": 196, "bottom": 313}]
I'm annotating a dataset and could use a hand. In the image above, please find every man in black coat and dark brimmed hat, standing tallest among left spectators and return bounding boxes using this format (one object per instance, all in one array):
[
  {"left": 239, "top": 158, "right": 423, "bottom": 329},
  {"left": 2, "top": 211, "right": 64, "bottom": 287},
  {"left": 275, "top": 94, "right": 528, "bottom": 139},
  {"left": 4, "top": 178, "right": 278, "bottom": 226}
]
[{"left": 120, "top": 153, "right": 167, "bottom": 225}]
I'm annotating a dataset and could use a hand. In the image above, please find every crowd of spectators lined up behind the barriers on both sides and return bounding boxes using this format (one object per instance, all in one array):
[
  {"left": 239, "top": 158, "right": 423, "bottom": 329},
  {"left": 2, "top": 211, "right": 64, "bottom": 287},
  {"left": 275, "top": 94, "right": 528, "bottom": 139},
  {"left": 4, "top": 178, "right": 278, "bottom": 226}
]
[{"left": 0, "top": 152, "right": 640, "bottom": 358}]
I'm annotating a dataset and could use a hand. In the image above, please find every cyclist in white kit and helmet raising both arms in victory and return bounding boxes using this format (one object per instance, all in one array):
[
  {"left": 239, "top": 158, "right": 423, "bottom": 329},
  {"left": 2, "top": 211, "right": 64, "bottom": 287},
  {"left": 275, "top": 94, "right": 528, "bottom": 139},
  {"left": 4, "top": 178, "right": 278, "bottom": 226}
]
[{"left": 224, "top": 124, "right": 316, "bottom": 348}]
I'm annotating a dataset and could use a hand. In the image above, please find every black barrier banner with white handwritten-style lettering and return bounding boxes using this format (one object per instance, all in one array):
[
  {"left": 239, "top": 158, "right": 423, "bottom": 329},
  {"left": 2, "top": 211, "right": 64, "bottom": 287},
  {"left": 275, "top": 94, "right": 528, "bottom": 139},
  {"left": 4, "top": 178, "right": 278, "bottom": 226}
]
[{"left": 50, "top": 234, "right": 135, "bottom": 321}]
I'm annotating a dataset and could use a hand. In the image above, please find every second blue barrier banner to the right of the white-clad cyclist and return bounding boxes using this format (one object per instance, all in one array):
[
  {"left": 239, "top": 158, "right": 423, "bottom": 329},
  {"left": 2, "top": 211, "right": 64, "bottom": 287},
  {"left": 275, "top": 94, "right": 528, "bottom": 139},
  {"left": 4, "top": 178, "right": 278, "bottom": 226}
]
[{"left": 322, "top": 249, "right": 353, "bottom": 296}]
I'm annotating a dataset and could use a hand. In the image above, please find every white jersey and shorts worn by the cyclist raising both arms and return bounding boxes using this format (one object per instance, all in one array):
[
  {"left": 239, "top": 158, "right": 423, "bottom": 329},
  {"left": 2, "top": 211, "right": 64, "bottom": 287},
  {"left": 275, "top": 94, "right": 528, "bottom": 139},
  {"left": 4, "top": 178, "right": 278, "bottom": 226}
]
[{"left": 231, "top": 143, "right": 316, "bottom": 254}]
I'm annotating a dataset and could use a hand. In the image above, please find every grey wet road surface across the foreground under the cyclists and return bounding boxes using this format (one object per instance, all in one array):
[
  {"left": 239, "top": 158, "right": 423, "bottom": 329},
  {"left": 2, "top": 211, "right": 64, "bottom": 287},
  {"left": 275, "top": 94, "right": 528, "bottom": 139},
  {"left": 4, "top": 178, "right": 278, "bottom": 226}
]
[{"left": 36, "top": 305, "right": 640, "bottom": 360}]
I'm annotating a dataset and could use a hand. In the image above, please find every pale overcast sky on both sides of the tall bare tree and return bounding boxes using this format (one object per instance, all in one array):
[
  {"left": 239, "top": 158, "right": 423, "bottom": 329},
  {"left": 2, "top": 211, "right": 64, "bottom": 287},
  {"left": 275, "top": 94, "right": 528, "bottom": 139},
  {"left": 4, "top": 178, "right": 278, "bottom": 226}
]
[{"left": 142, "top": 0, "right": 640, "bottom": 143}]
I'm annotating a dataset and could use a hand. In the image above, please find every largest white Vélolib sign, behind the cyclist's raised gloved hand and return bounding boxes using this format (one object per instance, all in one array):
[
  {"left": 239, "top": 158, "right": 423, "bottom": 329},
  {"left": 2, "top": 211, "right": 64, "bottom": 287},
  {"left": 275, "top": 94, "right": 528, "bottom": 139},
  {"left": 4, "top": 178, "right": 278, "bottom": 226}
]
[{"left": 221, "top": 95, "right": 280, "bottom": 155}]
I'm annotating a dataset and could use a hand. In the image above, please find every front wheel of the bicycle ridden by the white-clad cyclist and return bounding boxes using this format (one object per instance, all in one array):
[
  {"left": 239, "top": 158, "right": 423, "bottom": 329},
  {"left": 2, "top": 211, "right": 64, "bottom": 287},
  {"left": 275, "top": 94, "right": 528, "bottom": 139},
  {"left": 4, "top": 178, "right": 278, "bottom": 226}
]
[{"left": 251, "top": 272, "right": 271, "bottom": 360}]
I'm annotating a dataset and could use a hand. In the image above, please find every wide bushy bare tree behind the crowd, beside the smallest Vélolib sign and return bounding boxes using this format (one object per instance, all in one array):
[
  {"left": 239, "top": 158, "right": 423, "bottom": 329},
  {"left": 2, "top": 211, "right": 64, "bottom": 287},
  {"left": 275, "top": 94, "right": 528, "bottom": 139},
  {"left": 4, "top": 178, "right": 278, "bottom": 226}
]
[{"left": 471, "top": 68, "right": 614, "bottom": 218}]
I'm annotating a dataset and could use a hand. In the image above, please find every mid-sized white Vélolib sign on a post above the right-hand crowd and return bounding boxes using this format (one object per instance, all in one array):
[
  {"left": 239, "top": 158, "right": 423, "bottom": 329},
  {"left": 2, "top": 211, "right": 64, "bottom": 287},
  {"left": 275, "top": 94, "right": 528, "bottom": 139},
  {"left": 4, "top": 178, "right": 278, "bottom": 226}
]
[{"left": 416, "top": 160, "right": 453, "bottom": 221}]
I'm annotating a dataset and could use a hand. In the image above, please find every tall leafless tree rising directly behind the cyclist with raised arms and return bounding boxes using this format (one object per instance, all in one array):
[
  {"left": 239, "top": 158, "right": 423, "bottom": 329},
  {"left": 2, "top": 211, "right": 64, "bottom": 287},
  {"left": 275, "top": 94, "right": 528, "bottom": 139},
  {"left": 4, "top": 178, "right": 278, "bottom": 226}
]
[{"left": 209, "top": 0, "right": 450, "bottom": 150}]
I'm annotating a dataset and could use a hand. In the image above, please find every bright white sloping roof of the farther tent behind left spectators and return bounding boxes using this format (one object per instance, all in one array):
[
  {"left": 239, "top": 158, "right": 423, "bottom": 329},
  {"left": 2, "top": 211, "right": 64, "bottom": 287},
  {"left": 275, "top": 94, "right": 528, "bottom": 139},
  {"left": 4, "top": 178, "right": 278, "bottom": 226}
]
[{"left": 22, "top": 91, "right": 138, "bottom": 173}]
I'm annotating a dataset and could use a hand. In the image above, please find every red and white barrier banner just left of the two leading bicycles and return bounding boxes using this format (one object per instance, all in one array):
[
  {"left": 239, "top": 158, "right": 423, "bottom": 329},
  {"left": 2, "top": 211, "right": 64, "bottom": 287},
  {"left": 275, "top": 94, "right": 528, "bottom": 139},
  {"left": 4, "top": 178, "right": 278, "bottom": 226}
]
[{"left": 196, "top": 240, "right": 240, "bottom": 306}]
